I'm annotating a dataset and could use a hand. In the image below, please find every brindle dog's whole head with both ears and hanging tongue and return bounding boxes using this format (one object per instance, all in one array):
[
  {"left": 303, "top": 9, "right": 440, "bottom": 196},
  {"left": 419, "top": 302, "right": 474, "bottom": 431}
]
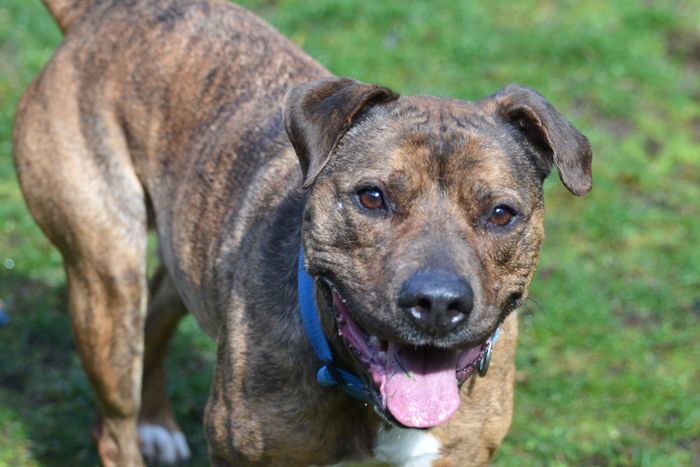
[{"left": 284, "top": 78, "right": 591, "bottom": 427}]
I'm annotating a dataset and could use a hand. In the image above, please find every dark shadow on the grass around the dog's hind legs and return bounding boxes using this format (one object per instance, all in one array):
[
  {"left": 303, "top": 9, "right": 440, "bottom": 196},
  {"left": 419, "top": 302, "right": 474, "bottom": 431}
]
[{"left": 0, "top": 271, "right": 213, "bottom": 466}]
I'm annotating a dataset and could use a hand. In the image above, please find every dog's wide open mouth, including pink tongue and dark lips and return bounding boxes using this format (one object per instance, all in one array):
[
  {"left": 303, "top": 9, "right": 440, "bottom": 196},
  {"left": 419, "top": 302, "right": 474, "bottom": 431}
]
[{"left": 331, "top": 288, "right": 487, "bottom": 428}]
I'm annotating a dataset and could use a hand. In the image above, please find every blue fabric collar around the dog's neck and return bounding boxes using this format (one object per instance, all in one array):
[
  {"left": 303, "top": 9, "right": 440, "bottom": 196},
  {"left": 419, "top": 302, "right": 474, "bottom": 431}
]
[{"left": 297, "top": 247, "right": 501, "bottom": 402}]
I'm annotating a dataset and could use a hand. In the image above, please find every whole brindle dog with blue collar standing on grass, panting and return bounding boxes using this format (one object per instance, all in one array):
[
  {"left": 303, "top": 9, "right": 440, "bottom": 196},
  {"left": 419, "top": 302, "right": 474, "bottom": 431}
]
[{"left": 13, "top": 0, "right": 592, "bottom": 466}]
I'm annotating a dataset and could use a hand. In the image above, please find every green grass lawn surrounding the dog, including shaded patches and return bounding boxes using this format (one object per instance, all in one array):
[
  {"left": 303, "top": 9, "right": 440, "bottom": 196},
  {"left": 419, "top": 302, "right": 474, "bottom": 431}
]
[{"left": 0, "top": 0, "right": 700, "bottom": 466}]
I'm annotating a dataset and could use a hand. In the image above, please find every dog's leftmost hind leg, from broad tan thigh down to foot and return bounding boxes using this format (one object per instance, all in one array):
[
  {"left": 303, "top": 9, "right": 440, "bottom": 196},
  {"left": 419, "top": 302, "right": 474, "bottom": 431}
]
[{"left": 14, "top": 75, "right": 148, "bottom": 466}]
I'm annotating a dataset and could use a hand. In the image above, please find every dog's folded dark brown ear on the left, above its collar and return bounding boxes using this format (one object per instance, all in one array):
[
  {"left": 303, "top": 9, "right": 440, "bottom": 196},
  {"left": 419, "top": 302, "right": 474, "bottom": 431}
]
[{"left": 283, "top": 78, "right": 399, "bottom": 188}]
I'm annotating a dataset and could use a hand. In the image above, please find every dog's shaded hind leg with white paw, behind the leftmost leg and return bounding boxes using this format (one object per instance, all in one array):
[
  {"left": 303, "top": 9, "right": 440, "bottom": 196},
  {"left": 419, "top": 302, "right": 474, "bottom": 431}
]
[{"left": 138, "top": 265, "right": 190, "bottom": 464}]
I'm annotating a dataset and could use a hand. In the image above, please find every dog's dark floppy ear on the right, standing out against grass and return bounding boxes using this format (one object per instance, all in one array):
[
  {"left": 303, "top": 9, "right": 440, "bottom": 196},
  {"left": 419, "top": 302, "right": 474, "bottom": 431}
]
[{"left": 486, "top": 85, "right": 593, "bottom": 196}]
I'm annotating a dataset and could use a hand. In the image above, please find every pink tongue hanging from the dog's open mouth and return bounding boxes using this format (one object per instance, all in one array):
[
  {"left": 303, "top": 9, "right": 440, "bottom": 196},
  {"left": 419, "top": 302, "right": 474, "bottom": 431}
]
[{"left": 381, "top": 342, "right": 459, "bottom": 428}]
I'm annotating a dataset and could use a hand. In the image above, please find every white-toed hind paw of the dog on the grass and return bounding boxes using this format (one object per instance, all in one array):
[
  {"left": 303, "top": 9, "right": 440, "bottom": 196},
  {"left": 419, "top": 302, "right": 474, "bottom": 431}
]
[{"left": 138, "top": 424, "right": 190, "bottom": 465}]
